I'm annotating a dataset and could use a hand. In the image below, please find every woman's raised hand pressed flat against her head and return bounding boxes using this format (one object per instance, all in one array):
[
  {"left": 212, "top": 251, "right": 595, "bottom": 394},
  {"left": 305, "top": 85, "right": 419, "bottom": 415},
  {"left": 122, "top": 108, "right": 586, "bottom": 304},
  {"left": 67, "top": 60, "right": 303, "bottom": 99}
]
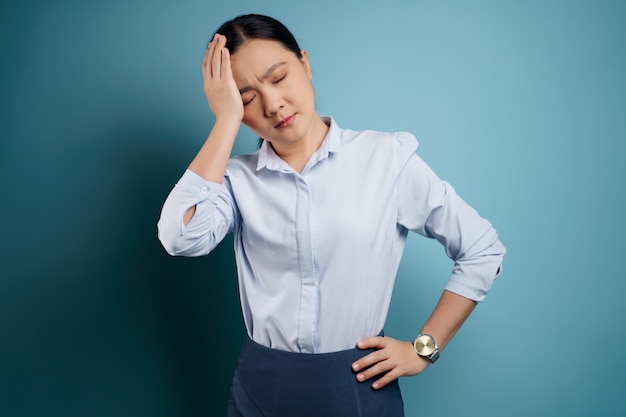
[{"left": 202, "top": 34, "right": 243, "bottom": 122}]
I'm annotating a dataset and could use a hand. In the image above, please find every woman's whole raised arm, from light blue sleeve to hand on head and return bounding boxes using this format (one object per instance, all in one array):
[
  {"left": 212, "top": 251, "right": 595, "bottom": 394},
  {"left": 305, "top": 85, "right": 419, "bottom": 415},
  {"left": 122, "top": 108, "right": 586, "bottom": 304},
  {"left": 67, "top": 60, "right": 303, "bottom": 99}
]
[{"left": 157, "top": 35, "right": 243, "bottom": 256}]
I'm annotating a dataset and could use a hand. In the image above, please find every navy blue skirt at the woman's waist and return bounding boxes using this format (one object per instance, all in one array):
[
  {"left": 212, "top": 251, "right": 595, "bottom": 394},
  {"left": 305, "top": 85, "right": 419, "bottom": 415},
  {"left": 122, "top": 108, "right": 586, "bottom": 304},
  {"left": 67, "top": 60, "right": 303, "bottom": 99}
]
[{"left": 228, "top": 337, "right": 404, "bottom": 417}]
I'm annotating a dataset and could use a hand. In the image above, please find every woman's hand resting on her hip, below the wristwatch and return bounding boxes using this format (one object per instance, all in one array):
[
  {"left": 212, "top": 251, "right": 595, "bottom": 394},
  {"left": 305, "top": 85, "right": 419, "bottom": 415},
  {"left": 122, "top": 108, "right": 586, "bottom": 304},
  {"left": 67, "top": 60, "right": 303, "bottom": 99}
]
[{"left": 352, "top": 336, "right": 430, "bottom": 389}]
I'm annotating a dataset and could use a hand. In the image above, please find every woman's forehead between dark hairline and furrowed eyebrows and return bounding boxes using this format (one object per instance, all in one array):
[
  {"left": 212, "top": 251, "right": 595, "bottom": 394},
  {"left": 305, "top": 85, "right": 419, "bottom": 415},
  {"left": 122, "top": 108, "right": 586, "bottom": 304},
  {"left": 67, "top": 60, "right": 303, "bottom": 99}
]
[{"left": 231, "top": 39, "right": 298, "bottom": 80}]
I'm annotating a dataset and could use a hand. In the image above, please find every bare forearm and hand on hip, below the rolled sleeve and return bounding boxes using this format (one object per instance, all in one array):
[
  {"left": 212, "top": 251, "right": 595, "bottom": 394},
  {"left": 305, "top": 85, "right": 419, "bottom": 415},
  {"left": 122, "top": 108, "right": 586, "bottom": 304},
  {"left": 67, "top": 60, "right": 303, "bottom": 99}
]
[{"left": 352, "top": 290, "right": 476, "bottom": 389}]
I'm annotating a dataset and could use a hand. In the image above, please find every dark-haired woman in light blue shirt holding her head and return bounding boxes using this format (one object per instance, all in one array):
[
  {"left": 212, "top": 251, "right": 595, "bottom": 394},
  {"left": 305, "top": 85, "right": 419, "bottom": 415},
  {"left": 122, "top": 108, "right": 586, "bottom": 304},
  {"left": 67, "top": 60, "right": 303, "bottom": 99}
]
[{"left": 158, "top": 15, "right": 505, "bottom": 417}]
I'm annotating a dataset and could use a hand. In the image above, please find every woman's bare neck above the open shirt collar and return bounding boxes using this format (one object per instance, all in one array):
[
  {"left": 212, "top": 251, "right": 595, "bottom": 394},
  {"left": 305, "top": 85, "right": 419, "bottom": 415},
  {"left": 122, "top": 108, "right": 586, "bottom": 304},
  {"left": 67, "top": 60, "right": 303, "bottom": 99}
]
[{"left": 271, "top": 116, "right": 329, "bottom": 173}]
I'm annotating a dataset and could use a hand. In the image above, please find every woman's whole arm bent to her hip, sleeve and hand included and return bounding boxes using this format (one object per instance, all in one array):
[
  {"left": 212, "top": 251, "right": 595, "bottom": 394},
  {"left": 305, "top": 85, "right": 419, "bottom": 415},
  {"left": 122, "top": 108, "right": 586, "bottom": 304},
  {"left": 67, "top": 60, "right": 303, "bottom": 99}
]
[{"left": 353, "top": 139, "right": 506, "bottom": 388}]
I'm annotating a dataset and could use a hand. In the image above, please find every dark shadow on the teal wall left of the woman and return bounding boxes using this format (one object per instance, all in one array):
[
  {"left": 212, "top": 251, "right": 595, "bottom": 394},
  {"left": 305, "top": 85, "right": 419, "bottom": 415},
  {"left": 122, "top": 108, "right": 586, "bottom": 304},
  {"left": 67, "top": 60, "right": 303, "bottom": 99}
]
[{"left": 0, "top": 116, "right": 245, "bottom": 417}]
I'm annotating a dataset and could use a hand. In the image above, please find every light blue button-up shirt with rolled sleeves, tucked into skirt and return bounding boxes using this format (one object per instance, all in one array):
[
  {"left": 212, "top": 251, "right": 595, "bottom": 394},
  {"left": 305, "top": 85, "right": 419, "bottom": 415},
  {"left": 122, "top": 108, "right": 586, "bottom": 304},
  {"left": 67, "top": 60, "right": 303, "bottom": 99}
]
[{"left": 158, "top": 118, "right": 506, "bottom": 353}]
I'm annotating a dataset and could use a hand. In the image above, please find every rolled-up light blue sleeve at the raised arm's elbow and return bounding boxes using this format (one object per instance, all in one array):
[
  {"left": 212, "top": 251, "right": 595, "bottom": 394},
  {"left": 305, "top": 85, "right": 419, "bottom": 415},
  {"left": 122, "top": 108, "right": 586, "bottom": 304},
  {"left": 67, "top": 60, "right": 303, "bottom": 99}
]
[{"left": 157, "top": 170, "right": 238, "bottom": 256}]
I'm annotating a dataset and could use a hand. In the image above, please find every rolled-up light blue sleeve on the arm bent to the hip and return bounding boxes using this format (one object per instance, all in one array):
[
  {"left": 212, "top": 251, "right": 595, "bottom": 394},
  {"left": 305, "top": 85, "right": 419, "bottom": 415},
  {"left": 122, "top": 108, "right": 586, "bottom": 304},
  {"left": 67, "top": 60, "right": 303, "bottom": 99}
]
[{"left": 397, "top": 138, "right": 506, "bottom": 301}]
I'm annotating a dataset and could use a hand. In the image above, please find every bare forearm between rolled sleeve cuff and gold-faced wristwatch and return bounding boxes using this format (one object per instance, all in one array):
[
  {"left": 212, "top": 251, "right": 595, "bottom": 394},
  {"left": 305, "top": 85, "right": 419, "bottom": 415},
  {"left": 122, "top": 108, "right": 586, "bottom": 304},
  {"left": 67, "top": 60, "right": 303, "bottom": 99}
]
[{"left": 421, "top": 290, "right": 476, "bottom": 350}]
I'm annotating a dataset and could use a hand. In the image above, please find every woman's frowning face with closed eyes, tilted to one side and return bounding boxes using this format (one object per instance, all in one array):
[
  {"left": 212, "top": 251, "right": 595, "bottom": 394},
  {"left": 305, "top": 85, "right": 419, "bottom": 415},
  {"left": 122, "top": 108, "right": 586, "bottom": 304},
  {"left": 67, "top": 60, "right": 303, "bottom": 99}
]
[{"left": 231, "top": 39, "right": 319, "bottom": 146}]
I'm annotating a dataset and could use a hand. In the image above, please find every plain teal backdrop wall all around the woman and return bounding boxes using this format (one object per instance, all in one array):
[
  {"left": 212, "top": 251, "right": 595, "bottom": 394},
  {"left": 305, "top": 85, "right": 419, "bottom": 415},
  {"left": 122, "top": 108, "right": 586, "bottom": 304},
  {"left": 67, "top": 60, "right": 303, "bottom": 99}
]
[{"left": 0, "top": 0, "right": 626, "bottom": 417}]
